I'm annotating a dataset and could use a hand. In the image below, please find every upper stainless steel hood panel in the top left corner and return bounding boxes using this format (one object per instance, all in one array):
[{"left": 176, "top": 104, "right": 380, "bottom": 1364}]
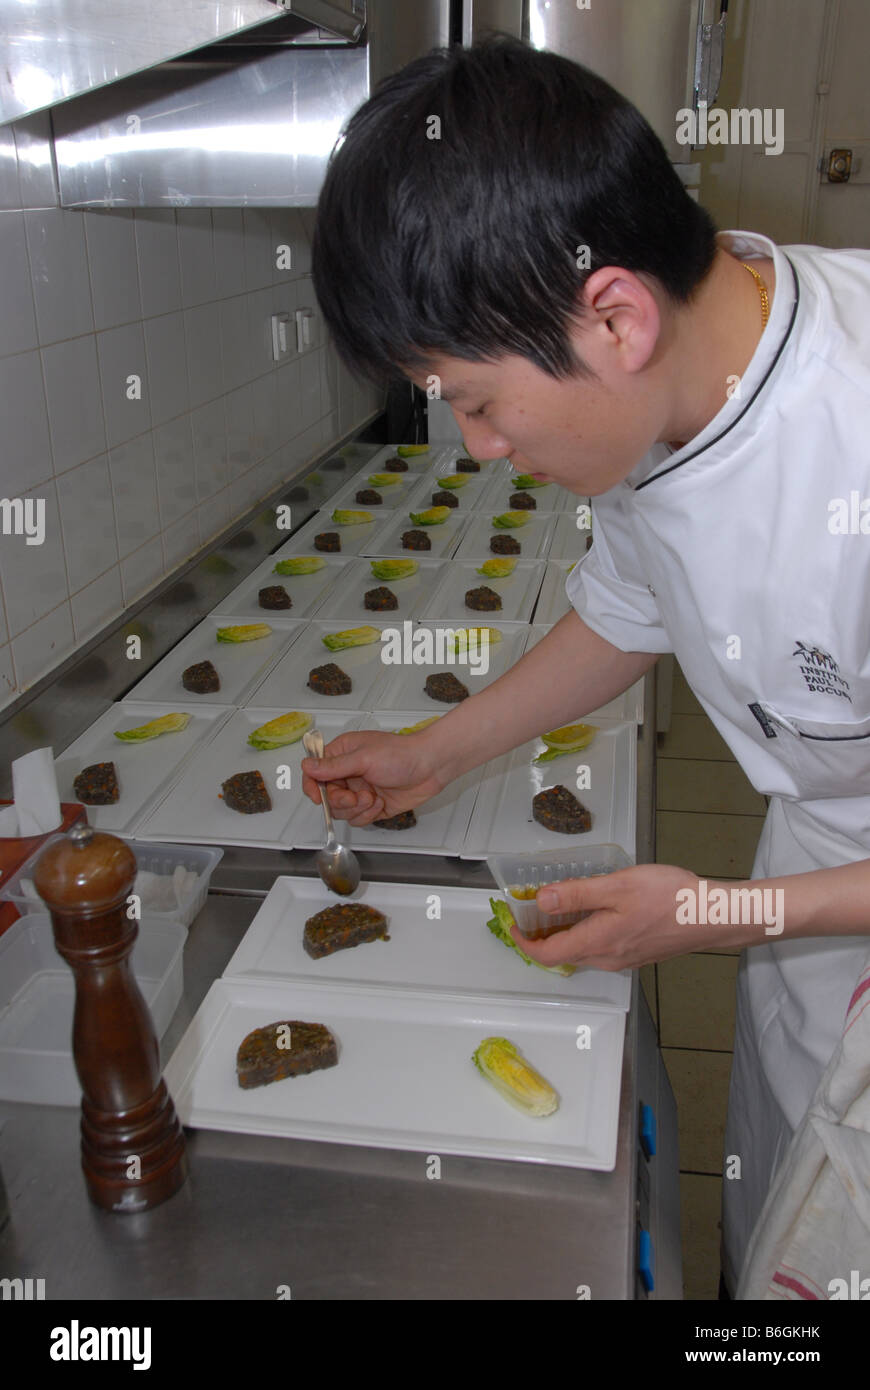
[{"left": 0, "top": 0, "right": 364, "bottom": 125}]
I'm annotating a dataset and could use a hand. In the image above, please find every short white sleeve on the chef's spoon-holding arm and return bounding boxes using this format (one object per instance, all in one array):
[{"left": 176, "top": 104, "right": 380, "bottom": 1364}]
[{"left": 566, "top": 495, "right": 674, "bottom": 652}]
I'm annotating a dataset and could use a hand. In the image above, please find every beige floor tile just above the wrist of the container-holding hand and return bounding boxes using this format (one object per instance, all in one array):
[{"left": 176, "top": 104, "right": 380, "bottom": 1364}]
[{"left": 656, "top": 810, "right": 764, "bottom": 878}]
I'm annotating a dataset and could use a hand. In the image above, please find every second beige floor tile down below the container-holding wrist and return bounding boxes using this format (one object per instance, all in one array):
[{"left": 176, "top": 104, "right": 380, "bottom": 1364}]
[{"left": 662, "top": 1048, "right": 731, "bottom": 1176}]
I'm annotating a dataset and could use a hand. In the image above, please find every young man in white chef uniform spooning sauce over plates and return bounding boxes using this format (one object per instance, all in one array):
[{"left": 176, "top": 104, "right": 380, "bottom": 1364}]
[{"left": 303, "top": 40, "right": 870, "bottom": 1291}]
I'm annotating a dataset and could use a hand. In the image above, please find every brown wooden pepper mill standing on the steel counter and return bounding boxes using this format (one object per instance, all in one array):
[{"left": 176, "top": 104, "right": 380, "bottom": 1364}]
[{"left": 33, "top": 824, "right": 188, "bottom": 1212}]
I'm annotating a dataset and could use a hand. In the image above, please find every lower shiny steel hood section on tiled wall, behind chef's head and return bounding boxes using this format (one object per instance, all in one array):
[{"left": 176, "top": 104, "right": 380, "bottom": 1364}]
[{"left": 44, "top": 0, "right": 450, "bottom": 209}]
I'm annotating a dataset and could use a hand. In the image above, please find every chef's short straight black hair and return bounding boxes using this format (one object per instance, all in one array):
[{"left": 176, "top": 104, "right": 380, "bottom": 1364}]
[{"left": 313, "top": 36, "right": 716, "bottom": 382}]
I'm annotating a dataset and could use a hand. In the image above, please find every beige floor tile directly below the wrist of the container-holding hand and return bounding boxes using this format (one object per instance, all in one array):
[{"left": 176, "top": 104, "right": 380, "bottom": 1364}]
[{"left": 657, "top": 954, "right": 738, "bottom": 1052}]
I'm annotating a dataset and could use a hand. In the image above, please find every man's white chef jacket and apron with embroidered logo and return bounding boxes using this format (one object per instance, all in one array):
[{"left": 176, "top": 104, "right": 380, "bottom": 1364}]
[{"left": 567, "top": 232, "right": 870, "bottom": 1287}]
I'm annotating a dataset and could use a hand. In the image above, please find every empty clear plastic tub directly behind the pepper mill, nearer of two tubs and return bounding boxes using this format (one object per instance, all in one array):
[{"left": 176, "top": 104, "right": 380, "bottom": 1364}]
[{"left": 0, "top": 912, "right": 188, "bottom": 1105}]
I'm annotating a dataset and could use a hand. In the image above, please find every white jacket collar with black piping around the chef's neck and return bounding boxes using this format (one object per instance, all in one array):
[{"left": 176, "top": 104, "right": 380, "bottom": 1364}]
[{"left": 624, "top": 231, "right": 801, "bottom": 492}]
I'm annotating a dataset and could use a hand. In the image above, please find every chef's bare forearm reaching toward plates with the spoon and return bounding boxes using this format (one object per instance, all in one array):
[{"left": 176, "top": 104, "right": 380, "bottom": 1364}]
[{"left": 427, "top": 612, "right": 657, "bottom": 780}]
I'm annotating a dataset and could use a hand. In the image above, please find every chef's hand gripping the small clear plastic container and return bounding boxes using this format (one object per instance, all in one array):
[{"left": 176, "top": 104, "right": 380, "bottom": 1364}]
[{"left": 511, "top": 865, "right": 759, "bottom": 970}]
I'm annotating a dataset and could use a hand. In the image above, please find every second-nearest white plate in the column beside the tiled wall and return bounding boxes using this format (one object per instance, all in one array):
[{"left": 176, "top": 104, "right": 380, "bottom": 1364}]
[{"left": 129, "top": 609, "right": 303, "bottom": 709}]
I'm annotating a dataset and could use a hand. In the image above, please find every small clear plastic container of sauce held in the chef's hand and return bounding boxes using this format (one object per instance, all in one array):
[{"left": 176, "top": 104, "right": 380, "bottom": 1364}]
[{"left": 486, "top": 845, "right": 634, "bottom": 941}]
